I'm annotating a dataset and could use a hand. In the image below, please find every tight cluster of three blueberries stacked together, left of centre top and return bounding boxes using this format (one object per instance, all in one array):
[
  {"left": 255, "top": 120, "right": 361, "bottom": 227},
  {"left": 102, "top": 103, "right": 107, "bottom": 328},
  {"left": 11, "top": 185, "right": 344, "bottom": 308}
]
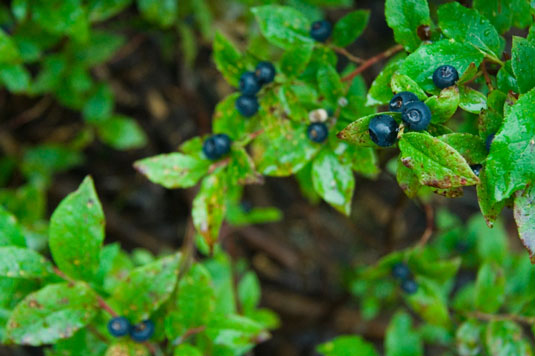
[{"left": 236, "top": 62, "right": 276, "bottom": 117}]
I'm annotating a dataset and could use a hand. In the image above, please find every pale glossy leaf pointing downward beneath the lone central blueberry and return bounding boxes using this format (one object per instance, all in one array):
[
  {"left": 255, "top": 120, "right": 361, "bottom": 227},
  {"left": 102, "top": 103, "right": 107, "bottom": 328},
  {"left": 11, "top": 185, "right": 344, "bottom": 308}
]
[{"left": 312, "top": 150, "right": 355, "bottom": 215}]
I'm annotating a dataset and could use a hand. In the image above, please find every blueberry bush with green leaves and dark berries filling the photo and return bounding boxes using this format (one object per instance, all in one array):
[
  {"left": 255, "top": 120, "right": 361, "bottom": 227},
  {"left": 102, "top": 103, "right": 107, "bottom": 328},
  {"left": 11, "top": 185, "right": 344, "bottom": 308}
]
[{"left": 0, "top": 0, "right": 535, "bottom": 356}]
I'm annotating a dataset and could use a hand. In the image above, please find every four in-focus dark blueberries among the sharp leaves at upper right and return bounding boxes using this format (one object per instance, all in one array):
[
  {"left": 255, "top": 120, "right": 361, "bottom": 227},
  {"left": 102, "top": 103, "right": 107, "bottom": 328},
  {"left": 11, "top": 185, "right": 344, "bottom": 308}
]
[{"left": 368, "top": 65, "right": 459, "bottom": 147}]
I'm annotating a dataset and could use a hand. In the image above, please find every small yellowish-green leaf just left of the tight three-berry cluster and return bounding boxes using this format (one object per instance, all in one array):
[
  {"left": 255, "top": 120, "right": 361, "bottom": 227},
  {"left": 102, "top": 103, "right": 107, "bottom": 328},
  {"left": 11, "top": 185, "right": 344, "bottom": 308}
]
[{"left": 214, "top": 32, "right": 247, "bottom": 87}]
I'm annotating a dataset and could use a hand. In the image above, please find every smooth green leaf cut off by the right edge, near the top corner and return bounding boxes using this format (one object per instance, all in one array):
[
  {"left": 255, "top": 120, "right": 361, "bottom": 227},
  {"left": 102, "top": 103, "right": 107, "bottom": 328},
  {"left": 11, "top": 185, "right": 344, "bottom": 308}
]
[{"left": 511, "top": 36, "right": 535, "bottom": 94}]
